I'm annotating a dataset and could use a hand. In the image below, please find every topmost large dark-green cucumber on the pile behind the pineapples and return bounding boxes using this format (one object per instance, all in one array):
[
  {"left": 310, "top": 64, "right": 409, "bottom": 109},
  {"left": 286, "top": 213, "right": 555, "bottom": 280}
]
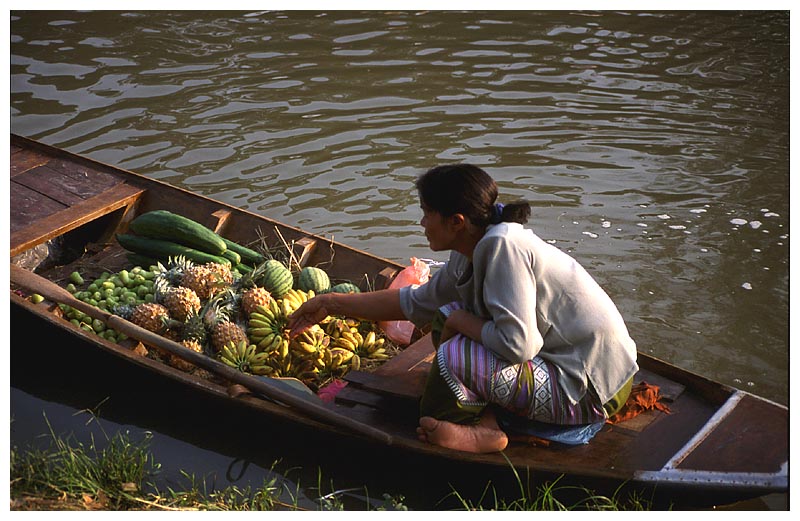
[{"left": 130, "top": 210, "right": 228, "bottom": 255}]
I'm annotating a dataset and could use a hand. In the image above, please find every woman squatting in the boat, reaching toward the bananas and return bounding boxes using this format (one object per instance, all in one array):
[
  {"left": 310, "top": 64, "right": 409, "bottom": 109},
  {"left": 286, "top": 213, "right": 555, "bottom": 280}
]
[{"left": 290, "top": 164, "right": 638, "bottom": 452}]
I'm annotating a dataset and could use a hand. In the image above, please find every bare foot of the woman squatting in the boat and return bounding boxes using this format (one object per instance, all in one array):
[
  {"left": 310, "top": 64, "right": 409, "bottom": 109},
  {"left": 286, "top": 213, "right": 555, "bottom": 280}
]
[{"left": 417, "top": 409, "right": 508, "bottom": 452}]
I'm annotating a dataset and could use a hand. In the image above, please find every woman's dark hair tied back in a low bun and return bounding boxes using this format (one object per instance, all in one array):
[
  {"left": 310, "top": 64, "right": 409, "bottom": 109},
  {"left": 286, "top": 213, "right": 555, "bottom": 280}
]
[{"left": 416, "top": 164, "right": 531, "bottom": 227}]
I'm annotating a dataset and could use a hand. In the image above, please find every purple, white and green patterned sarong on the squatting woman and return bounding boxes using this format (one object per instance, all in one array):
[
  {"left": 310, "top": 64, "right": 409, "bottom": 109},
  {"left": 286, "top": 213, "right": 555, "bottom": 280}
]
[{"left": 422, "top": 303, "right": 606, "bottom": 425}]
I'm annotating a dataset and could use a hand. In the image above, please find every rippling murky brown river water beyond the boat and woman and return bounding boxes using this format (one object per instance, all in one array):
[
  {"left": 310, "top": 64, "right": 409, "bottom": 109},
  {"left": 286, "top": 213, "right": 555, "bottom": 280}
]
[{"left": 10, "top": 11, "right": 789, "bottom": 508}]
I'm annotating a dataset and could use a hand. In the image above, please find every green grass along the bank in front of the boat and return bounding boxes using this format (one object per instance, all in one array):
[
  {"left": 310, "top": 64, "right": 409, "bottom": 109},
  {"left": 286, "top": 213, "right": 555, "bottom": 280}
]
[{"left": 10, "top": 412, "right": 650, "bottom": 511}]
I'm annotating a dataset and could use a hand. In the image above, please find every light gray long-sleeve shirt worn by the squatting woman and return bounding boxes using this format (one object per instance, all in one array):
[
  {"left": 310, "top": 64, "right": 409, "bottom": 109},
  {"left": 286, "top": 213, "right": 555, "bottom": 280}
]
[{"left": 400, "top": 223, "right": 638, "bottom": 403}]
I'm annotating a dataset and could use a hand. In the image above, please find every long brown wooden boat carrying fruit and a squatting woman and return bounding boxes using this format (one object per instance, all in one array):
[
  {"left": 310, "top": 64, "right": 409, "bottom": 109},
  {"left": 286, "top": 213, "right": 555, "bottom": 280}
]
[{"left": 10, "top": 135, "right": 789, "bottom": 506}]
